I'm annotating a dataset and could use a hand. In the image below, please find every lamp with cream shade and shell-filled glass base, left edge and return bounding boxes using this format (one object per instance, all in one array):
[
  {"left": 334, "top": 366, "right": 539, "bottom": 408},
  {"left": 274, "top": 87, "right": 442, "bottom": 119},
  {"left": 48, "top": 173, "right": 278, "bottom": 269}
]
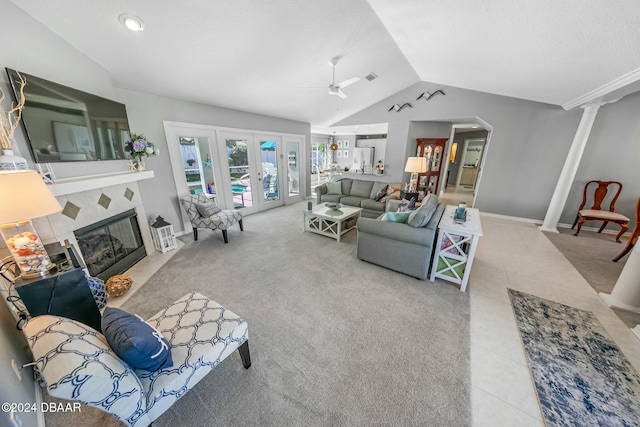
[{"left": 0, "top": 170, "right": 62, "bottom": 279}]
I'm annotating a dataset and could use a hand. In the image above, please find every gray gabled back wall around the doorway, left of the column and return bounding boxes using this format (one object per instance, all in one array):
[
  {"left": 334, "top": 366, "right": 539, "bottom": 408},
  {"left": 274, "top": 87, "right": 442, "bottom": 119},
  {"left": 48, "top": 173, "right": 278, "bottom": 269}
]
[{"left": 337, "top": 82, "right": 582, "bottom": 220}]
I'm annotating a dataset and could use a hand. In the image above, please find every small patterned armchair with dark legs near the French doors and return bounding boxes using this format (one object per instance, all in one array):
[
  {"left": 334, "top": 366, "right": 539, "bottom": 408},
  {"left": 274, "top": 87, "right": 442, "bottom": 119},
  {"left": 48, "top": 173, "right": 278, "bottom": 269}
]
[{"left": 180, "top": 194, "right": 244, "bottom": 243}]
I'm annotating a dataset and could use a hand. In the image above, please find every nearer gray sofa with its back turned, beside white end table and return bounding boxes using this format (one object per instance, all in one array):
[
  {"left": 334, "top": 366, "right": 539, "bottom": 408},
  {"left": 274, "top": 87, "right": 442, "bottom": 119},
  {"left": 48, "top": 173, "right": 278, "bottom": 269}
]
[{"left": 357, "top": 196, "right": 446, "bottom": 279}]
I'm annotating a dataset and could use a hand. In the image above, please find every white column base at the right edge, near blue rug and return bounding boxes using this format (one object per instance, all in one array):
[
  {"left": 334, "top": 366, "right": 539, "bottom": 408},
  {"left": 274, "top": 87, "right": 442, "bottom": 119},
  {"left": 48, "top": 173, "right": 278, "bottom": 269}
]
[{"left": 600, "top": 245, "right": 640, "bottom": 313}]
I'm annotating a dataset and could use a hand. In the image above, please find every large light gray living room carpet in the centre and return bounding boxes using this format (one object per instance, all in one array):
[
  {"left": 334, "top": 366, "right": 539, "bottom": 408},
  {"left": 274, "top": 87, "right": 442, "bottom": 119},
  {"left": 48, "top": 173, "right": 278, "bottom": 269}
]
[{"left": 47, "top": 202, "right": 471, "bottom": 427}]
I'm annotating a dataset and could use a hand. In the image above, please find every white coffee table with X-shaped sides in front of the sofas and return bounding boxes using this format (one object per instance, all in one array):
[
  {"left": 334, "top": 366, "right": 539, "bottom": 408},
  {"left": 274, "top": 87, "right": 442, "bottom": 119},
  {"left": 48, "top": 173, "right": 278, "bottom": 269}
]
[{"left": 304, "top": 203, "right": 362, "bottom": 242}]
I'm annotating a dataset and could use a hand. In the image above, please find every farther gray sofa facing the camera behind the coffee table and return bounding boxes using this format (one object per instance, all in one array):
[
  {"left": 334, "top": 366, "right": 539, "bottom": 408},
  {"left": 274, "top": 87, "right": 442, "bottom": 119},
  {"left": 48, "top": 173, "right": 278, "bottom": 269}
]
[{"left": 315, "top": 178, "right": 402, "bottom": 218}]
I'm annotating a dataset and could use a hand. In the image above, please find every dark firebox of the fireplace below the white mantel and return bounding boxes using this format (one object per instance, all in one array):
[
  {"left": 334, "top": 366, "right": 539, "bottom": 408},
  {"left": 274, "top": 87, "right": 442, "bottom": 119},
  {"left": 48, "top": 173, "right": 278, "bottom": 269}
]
[{"left": 74, "top": 209, "right": 147, "bottom": 280}]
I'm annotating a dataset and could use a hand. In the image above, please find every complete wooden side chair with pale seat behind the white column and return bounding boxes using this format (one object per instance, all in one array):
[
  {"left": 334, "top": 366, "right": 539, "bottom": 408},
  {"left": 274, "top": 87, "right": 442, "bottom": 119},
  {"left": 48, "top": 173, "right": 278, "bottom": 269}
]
[{"left": 571, "top": 181, "right": 629, "bottom": 243}]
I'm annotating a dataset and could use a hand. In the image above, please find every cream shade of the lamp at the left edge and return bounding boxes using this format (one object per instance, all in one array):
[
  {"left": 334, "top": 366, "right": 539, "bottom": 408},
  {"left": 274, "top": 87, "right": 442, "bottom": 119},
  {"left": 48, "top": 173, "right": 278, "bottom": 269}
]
[{"left": 0, "top": 170, "right": 62, "bottom": 224}]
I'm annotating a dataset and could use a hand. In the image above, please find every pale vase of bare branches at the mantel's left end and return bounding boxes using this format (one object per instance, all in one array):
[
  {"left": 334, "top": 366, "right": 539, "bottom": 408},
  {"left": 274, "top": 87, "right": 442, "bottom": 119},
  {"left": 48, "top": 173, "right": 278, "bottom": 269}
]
[{"left": 0, "top": 73, "right": 29, "bottom": 170}]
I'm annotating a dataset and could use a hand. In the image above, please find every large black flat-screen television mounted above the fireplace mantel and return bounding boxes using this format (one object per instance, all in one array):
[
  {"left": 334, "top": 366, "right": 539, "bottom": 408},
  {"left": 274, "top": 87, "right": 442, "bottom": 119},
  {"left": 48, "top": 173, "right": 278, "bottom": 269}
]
[{"left": 7, "top": 68, "right": 129, "bottom": 163}]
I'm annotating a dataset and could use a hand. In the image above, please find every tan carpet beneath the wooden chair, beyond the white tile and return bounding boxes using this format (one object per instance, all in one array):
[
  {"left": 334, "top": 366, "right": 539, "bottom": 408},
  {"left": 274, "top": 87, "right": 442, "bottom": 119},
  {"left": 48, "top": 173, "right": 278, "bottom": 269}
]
[{"left": 544, "top": 228, "right": 640, "bottom": 328}]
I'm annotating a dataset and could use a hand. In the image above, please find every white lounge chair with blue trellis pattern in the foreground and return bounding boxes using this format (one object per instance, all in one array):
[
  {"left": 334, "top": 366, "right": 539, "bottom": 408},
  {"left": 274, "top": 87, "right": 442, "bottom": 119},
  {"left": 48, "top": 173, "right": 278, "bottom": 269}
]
[{"left": 24, "top": 292, "right": 251, "bottom": 426}]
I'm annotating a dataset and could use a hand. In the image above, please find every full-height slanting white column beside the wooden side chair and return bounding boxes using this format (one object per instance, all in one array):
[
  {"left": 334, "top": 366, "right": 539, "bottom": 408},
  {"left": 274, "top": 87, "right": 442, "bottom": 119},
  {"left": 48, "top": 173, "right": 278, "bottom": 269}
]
[{"left": 540, "top": 104, "right": 604, "bottom": 233}]
